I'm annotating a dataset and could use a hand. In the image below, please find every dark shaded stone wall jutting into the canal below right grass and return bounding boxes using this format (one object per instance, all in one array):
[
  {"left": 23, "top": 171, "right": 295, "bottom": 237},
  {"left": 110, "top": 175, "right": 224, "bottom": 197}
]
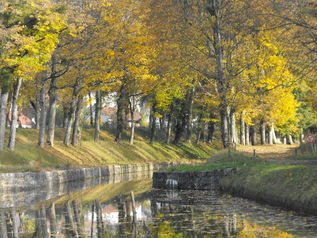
[{"left": 153, "top": 168, "right": 235, "bottom": 190}]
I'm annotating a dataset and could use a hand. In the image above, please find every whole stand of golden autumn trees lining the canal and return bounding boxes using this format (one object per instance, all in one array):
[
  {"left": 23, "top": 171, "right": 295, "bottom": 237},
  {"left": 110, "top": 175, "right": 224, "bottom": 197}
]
[{"left": 0, "top": 0, "right": 316, "bottom": 150}]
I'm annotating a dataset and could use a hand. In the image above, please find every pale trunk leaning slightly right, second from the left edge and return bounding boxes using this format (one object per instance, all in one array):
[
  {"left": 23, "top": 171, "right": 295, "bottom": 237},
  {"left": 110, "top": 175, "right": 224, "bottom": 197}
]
[{"left": 8, "top": 78, "right": 22, "bottom": 150}]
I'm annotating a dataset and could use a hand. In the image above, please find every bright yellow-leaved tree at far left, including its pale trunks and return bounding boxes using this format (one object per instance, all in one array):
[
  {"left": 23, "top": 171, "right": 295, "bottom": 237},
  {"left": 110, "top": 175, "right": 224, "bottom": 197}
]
[{"left": 0, "top": 1, "right": 64, "bottom": 149}]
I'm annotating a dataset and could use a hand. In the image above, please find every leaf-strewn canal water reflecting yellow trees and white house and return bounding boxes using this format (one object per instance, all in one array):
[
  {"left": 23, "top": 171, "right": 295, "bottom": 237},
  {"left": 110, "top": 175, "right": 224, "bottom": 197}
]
[{"left": 0, "top": 172, "right": 317, "bottom": 238}]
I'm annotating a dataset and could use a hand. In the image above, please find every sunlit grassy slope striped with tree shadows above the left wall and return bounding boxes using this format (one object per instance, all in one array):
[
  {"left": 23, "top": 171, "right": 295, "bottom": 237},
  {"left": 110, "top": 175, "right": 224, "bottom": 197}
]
[{"left": 0, "top": 129, "right": 215, "bottom": 172}]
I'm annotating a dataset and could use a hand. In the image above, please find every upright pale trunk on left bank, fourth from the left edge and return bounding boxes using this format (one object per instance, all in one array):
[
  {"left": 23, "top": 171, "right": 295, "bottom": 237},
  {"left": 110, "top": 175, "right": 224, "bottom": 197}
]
[{"left": 46, "top": 78, "right": 57, "bottom": 147}]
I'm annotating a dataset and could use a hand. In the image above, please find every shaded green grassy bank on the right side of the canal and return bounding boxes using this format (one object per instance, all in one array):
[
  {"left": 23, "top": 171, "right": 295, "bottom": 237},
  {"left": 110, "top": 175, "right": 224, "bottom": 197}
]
[{"left": 170, "top": 152, "right": 317, "bottom": 214}]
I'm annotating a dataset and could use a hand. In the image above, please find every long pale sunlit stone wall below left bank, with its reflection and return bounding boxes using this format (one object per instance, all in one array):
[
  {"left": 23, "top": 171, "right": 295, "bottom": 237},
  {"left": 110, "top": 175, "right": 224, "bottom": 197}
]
[{"left": 0, "top": 163, "right": 175, "bottom": 208}]
